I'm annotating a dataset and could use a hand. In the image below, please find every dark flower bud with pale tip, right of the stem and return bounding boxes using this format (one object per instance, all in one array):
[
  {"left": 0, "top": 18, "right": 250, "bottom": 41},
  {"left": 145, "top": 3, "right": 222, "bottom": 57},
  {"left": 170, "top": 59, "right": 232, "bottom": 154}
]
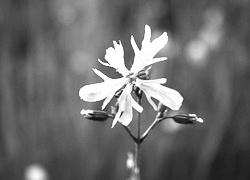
[{"left": 172, "top": 114, "right": 203, "bottom": 124}]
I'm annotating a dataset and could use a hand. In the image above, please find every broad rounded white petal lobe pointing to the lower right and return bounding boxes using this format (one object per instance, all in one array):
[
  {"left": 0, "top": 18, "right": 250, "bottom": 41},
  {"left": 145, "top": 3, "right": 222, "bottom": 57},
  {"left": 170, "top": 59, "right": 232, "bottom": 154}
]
[{"left": 139, "top": 82, "right": 183, "bottom": 110}]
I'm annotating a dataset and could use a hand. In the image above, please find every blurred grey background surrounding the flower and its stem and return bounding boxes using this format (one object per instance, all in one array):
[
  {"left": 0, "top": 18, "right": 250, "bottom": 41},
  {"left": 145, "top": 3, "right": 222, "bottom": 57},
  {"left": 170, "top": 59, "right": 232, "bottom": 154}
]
[{"left": 0, "top": 0, "right": 250, "bottom": 180}]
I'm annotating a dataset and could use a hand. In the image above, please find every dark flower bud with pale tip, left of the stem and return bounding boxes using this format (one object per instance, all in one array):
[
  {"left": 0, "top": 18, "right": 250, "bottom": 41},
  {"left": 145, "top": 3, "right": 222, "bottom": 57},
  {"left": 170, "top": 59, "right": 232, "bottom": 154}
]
[{"left": 81, "top": 109, "right": 112, "bottom": 121}]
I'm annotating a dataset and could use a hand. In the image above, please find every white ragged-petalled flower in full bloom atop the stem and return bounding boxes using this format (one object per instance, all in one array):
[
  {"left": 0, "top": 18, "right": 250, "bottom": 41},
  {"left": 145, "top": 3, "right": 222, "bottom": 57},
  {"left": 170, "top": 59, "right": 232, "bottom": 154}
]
[{"left": 79, "top": 25, "right": 183, "bottom": 127}]
